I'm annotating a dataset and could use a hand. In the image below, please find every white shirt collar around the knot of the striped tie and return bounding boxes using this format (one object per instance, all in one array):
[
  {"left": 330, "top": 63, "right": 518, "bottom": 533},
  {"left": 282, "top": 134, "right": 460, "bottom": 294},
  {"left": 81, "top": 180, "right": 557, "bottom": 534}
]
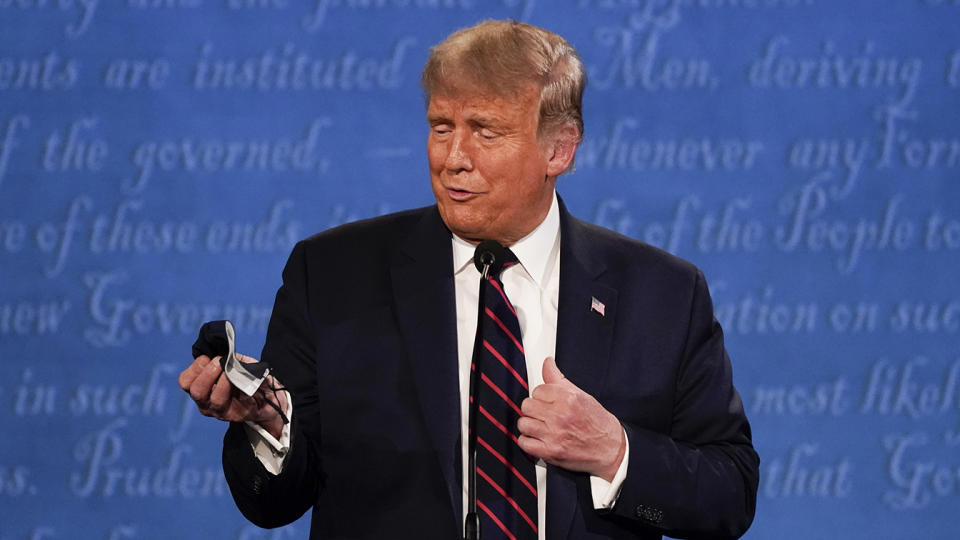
[{"left": 453, "top": 192, "right": 560, "bottom": 287}]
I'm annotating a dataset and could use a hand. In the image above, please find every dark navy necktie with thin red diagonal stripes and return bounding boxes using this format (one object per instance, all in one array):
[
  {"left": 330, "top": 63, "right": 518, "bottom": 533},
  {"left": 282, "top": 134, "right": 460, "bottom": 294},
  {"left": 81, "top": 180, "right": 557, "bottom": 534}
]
[{"left": 470, "top": 251, "right": 537, "bottom": 540}]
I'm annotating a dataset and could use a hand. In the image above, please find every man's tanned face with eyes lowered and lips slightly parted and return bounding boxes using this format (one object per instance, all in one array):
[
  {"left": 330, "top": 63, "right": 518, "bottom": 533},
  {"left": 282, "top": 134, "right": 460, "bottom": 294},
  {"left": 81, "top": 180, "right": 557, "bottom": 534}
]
[{"left": 427, "top": 85, "right": 557, "bottom": 246}]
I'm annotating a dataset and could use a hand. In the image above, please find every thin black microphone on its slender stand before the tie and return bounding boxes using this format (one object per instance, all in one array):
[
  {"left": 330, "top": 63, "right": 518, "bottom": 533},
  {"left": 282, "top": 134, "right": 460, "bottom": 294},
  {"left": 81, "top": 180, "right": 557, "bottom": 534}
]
[{"left": 463, "top": 240, "right": 507, "bottom": 540}]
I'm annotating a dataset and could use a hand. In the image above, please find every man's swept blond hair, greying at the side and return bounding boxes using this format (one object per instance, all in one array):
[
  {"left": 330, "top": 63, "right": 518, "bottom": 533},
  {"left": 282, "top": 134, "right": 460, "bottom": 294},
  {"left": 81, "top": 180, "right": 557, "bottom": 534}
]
[{"left": 420, "top": 20, "right": 587, "bottom": 142}]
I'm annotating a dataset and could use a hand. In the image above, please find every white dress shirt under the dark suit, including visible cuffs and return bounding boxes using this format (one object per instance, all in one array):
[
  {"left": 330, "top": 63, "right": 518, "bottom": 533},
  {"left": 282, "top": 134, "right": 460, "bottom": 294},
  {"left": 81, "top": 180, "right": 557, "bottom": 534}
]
[{"left": 245, "top": 193, "right": 630, "bottom": 540}]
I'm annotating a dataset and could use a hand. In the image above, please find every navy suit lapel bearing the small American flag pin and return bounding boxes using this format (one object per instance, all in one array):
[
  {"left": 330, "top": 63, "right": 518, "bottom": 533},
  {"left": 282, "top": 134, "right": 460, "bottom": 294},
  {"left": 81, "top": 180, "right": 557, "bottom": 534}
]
[{"left": 546, "top": 201, "right": 618, "bottom": 538}]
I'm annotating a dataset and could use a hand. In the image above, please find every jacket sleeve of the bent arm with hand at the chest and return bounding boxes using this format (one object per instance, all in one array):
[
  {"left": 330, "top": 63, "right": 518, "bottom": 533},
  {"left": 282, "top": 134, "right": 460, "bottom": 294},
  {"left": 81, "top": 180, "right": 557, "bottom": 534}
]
[{"left": 613, "top": 270, "right": 759, "bottom": 538}]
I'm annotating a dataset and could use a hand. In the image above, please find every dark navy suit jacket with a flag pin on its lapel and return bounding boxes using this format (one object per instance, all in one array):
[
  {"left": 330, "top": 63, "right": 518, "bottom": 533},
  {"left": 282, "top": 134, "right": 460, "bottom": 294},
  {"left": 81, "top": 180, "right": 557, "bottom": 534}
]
[{"left": 223, "top": 202, "right": 758, "bottom": 540}]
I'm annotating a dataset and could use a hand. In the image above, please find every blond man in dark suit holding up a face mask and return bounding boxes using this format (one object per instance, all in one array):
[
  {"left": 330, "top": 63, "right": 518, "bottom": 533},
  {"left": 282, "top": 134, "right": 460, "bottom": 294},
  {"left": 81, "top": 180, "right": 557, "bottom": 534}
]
[{"left": 180, "top": 21, "right": 758, "bottom": 539}]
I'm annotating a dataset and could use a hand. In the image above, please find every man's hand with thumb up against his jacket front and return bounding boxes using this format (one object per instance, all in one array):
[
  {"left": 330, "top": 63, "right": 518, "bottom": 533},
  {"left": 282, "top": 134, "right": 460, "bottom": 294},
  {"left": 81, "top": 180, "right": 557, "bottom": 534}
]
[{"left": 517, "top": 357, "right": 627, "bottom": 482}]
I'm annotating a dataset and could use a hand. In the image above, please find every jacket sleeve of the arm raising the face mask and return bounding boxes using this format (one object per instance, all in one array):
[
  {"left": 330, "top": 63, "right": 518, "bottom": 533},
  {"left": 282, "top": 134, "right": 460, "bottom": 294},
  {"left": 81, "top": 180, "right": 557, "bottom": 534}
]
[{"left": 223, "top": 243, "right": 324, "bottom": 528}]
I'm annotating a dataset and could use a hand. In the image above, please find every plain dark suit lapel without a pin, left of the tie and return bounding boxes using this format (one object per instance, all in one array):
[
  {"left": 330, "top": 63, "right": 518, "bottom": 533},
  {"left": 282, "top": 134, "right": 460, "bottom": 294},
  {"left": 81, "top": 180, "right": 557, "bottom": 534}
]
[{"left": 390, "top": 207, "right": 463, "bottom": 529}]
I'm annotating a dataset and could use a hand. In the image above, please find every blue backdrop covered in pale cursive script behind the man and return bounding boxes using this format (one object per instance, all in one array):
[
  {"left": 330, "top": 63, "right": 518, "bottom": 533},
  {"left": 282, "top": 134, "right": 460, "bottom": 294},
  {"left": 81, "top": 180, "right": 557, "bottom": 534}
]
[{"left": 0, "top": 0, "right": 960, "bottom": 540}]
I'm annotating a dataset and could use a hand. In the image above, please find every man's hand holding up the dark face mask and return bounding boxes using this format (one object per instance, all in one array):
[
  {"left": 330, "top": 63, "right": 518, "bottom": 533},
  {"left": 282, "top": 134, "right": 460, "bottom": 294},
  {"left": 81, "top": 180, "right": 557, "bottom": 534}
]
[{"left": 178, "top": 354, "right": 287, "bottom": 439}]
